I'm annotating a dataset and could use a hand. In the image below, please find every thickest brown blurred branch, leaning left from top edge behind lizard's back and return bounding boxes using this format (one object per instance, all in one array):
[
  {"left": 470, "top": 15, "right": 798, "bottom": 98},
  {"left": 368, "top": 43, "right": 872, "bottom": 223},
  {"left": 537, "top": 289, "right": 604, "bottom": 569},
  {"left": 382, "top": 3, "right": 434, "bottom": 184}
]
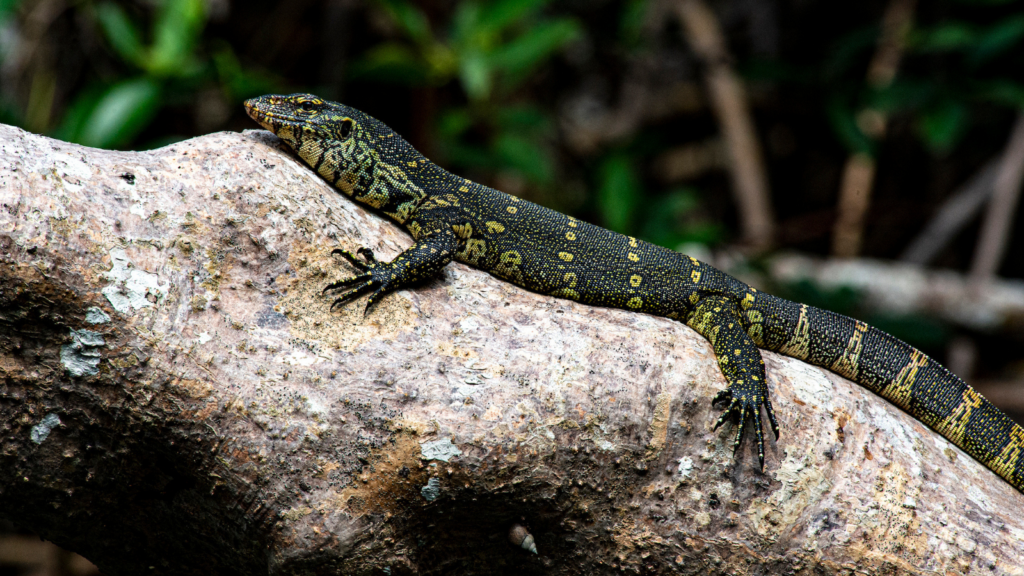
[{"left": 677, "top": 0, "right": 775, "bottom": 250}]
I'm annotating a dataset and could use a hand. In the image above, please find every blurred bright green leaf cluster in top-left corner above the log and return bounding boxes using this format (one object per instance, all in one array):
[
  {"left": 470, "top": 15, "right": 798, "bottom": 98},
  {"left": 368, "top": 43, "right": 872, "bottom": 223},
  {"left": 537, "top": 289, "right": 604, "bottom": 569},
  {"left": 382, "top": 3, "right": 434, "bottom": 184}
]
[{"left": 0, "top": 0, "right": 281, "bottom": 149}]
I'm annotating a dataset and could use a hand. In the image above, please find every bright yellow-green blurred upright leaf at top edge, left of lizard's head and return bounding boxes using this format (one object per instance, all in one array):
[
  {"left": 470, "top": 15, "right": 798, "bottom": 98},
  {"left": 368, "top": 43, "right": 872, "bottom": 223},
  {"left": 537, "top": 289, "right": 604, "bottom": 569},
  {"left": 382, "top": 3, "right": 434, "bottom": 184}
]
[{"left": 146, "top": 0, "right": 206, "bottom": 76}]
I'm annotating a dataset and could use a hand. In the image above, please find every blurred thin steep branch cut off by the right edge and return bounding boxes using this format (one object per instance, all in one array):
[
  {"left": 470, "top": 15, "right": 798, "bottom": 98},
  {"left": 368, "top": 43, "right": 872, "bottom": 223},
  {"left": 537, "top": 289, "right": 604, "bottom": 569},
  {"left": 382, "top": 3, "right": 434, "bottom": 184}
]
[{"left": 971, "top": 112, "right": 1024, "bottom": 283}]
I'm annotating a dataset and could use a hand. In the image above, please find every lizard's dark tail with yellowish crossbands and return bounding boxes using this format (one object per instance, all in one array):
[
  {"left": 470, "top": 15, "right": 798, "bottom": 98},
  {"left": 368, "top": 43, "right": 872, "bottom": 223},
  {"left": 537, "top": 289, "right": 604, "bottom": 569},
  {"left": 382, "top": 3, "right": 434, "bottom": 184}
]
[{"left": 748, "top": 296, "right": 1024, "bottom": 493}]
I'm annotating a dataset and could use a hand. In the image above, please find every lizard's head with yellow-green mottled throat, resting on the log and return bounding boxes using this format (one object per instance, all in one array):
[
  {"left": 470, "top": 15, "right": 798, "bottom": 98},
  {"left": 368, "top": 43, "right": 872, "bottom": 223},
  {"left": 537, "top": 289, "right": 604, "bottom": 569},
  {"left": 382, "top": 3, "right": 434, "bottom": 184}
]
[{"left": 245, "top": 94, "right": 382, "bottom": 196}]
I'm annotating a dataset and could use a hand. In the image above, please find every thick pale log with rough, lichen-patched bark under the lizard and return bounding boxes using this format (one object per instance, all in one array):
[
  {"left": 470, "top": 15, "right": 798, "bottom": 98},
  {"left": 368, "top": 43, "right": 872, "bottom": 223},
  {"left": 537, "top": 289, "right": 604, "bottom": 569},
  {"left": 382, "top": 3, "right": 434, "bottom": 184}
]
[{"left": 0, "top": 126, "right": 1024, "bottom": 576}]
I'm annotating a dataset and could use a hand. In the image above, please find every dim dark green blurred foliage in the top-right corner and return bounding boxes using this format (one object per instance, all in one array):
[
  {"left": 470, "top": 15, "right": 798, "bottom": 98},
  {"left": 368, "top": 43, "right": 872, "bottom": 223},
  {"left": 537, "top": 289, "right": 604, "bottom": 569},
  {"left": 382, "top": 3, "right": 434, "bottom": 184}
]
[{"left": 822, "top": 0, "right": 1024, "bottom": 156}]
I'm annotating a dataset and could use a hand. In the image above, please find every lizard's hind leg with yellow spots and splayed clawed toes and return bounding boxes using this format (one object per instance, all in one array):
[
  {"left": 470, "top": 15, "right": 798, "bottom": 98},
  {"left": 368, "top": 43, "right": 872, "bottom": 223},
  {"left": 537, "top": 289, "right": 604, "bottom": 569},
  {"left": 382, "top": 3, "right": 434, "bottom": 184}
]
[{"left": 686, "top": 296, "right": 778, "bottom": 470}]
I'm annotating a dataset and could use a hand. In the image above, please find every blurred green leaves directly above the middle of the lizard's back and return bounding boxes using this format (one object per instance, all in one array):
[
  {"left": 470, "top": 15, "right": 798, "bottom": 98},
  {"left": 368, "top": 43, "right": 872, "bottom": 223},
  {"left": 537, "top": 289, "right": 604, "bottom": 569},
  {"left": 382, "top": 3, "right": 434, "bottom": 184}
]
[{"left": 352, "top": 0, "right": 723, "bottom": 248}]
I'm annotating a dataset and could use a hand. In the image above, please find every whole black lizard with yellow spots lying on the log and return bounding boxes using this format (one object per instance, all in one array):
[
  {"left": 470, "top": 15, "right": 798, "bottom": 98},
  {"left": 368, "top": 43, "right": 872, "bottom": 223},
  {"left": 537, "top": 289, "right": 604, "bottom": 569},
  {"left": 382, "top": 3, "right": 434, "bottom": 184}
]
[{"left": 246, "top": 94, "right": 1024, "bottom": 493}]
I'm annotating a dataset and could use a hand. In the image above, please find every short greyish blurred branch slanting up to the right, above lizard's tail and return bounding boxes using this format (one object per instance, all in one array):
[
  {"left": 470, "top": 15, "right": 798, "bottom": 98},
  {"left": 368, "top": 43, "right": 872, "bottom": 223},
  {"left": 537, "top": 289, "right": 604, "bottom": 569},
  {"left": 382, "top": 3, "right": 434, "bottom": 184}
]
[{"left": 899, "top": 159, "right": 999, "bottom": 265}]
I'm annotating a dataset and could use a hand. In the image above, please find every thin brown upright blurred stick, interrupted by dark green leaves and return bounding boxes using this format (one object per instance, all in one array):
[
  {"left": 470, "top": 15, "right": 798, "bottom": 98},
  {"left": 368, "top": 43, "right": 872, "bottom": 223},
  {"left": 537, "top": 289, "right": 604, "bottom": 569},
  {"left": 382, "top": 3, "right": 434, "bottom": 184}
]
[{"left": 833, "top": 0, "right": 915, "bottom": 258}]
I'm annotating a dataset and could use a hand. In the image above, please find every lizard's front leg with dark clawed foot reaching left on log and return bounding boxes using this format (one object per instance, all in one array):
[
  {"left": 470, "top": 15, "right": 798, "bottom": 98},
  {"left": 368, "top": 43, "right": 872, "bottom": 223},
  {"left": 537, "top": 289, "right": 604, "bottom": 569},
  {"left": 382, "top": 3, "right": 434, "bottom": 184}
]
[{"left": 324, "top": 219, "right": 458, "bottom": 311}]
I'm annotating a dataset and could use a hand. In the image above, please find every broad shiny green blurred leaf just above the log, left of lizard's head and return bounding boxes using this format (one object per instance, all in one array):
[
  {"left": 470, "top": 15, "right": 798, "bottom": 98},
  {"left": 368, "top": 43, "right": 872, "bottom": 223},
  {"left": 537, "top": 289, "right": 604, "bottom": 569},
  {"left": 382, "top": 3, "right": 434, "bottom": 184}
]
[{"left": 73, "top": 78, "right": 160, "bottom": 148}]
